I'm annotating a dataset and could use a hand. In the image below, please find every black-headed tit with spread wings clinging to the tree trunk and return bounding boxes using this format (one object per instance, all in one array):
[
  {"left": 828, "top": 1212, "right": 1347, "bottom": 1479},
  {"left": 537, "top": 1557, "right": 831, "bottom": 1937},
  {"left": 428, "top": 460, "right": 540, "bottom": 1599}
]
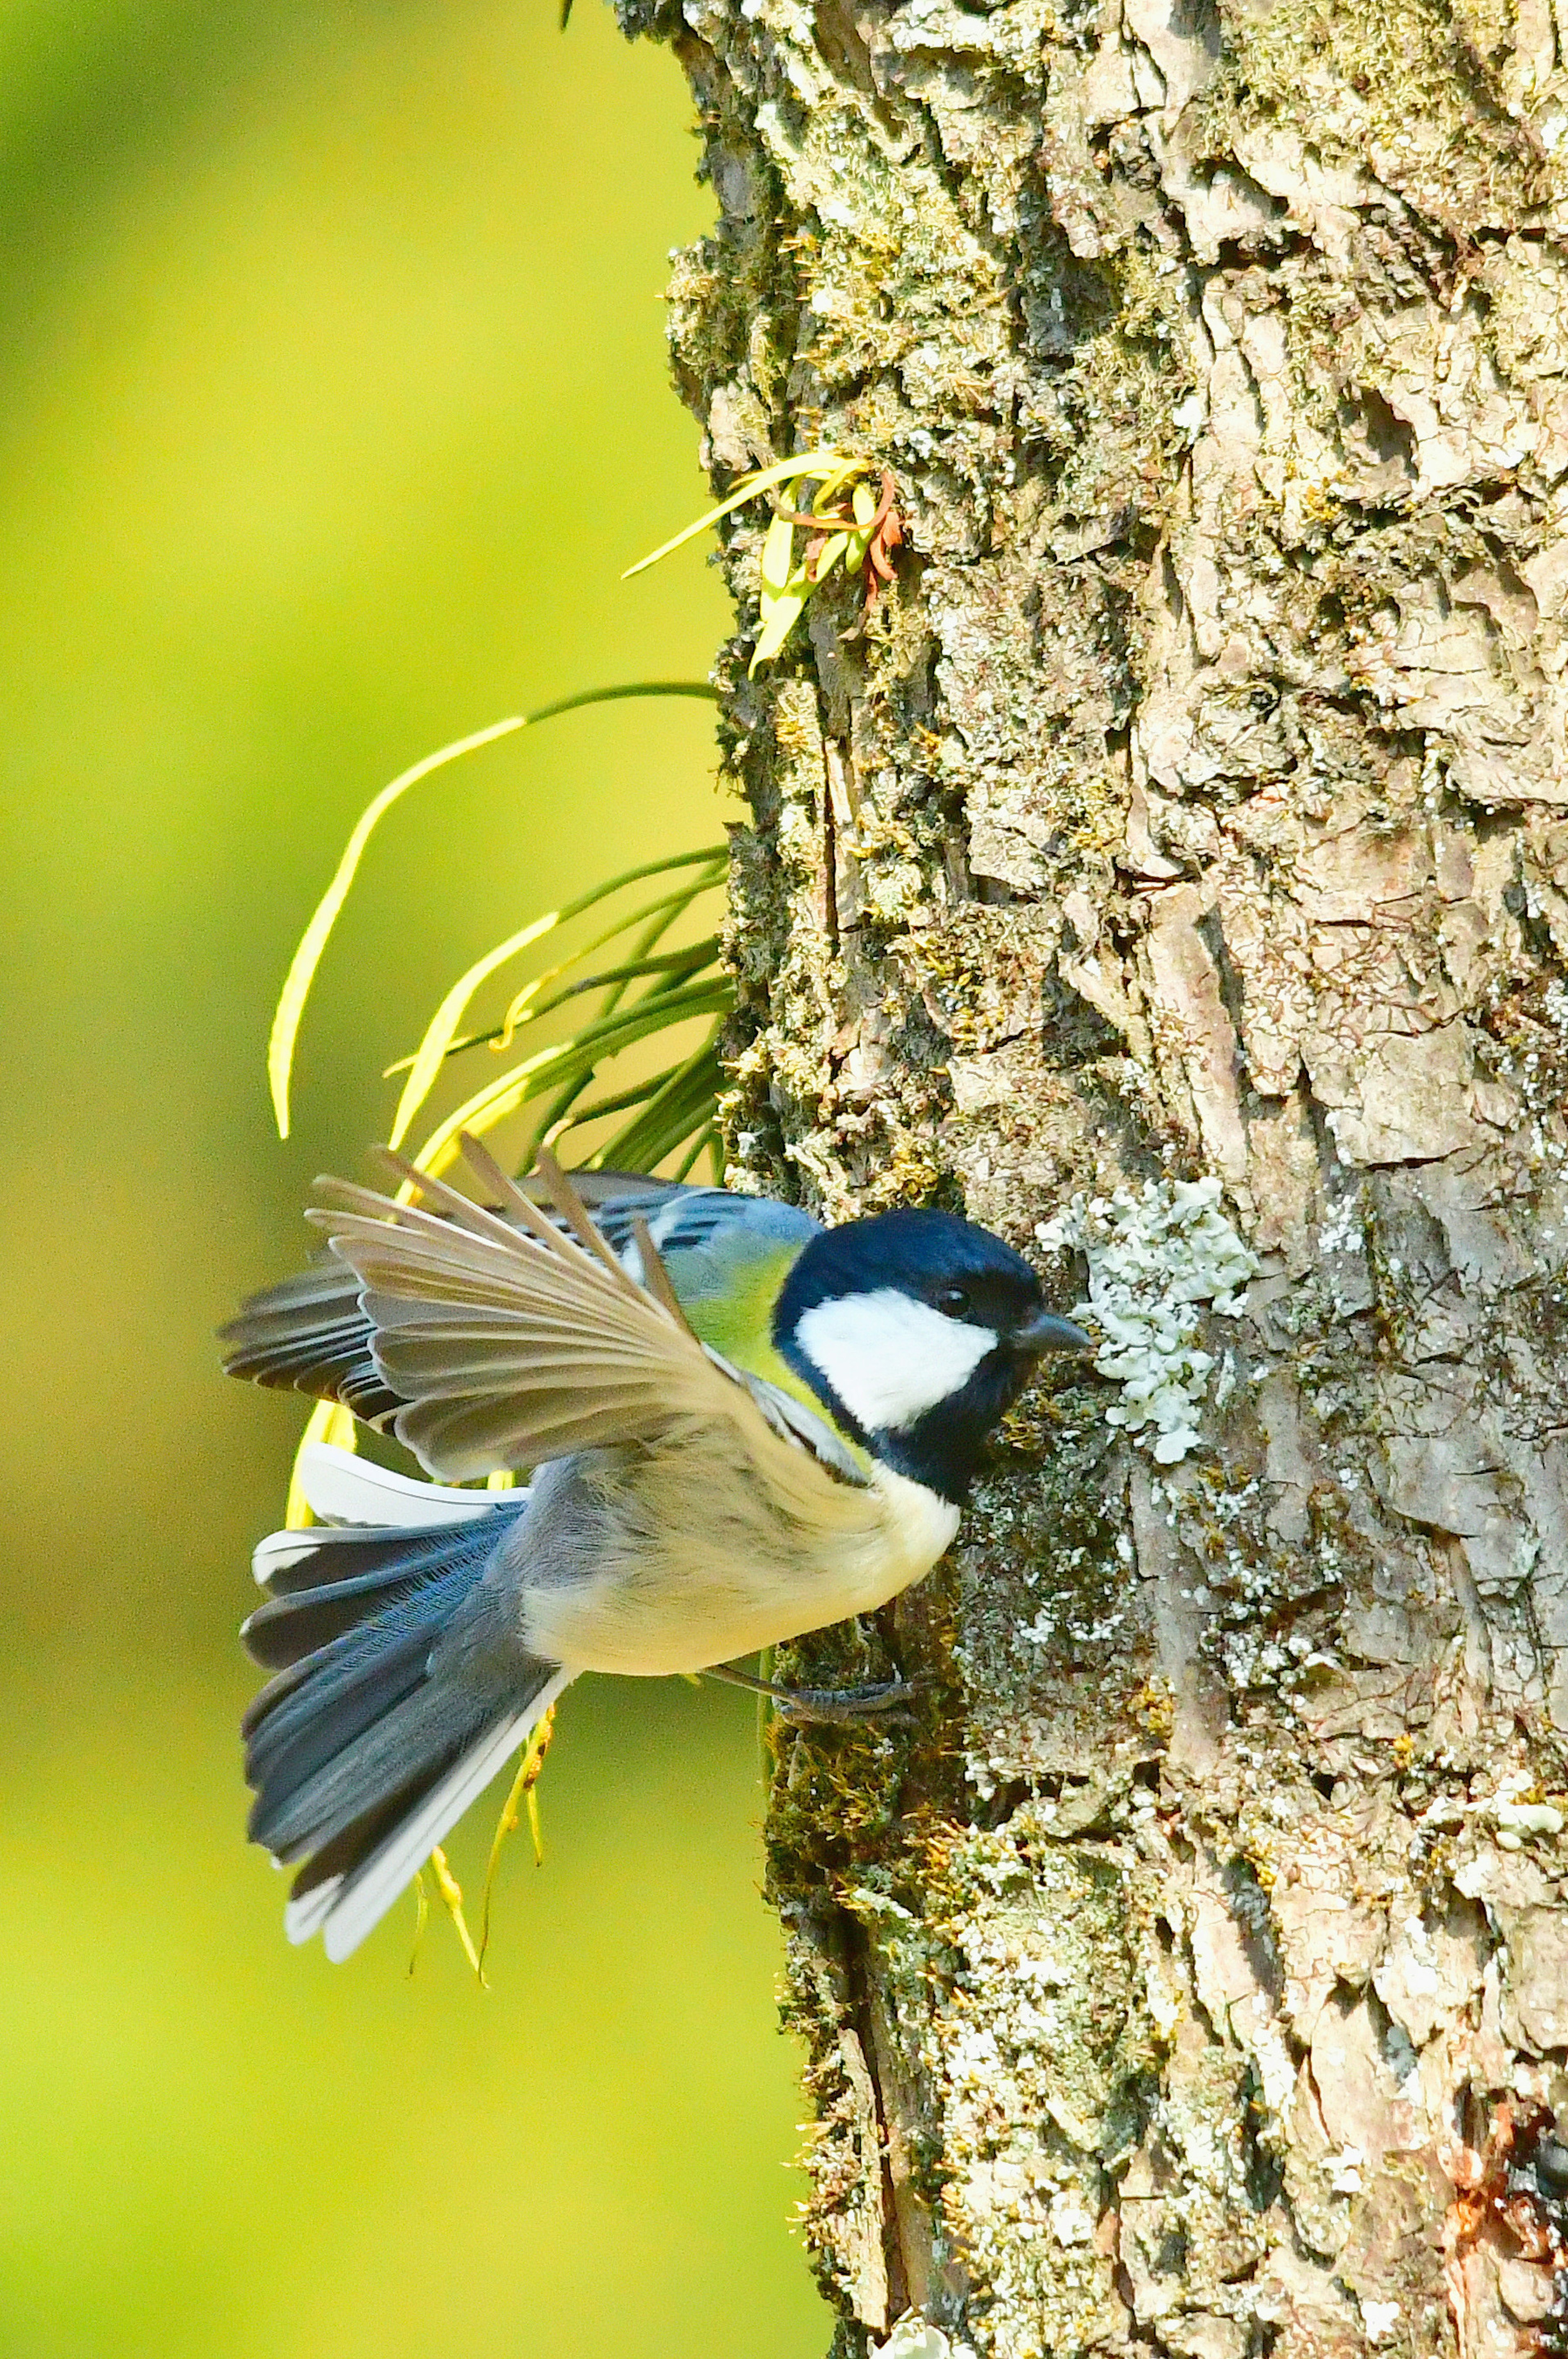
[{"left": 219, "top": 1135, "right": 1092, "bottom": 1960}]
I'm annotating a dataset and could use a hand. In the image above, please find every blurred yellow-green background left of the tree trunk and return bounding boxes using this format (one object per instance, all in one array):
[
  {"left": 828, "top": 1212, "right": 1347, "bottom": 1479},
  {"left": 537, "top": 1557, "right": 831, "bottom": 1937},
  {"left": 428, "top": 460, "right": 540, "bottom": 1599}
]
[{"left": 0, "top": 0, "right": 825, "bottom": 2359}]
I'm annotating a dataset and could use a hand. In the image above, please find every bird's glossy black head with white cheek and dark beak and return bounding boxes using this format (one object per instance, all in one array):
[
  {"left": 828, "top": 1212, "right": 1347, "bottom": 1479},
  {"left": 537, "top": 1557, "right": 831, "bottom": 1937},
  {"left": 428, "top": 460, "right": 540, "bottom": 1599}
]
[{"left": 773, "top": 1213, "right": 1089, "bottom": 1503}]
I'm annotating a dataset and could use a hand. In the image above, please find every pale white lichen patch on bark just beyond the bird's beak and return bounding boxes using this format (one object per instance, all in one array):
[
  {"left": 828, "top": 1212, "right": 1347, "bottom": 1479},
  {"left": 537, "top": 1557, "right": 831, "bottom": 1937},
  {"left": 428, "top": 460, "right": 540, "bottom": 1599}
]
[{"left": 1035, "top": 1180, "right": 1259, "bottom": 1467}]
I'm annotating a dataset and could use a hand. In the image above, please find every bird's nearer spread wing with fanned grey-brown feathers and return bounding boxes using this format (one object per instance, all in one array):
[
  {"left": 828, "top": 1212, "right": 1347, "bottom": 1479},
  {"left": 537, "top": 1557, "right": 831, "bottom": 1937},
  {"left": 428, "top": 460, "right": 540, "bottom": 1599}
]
[{"left": 309, "top": 1142, "right": 870, "bottom": 1526}]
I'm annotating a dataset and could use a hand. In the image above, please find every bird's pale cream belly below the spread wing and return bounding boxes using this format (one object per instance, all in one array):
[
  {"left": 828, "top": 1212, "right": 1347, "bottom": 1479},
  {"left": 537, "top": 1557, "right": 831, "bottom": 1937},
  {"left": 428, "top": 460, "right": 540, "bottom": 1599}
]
[{"left": 526, "top": 1467, "right": 957, "bottom": 1677}]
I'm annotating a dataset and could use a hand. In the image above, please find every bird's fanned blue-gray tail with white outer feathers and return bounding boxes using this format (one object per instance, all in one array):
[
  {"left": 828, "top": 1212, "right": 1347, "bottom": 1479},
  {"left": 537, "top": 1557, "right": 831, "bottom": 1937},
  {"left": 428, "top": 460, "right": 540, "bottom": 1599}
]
[{"left": 243, "top": 1448, "right": 570, "bottom": 1960}]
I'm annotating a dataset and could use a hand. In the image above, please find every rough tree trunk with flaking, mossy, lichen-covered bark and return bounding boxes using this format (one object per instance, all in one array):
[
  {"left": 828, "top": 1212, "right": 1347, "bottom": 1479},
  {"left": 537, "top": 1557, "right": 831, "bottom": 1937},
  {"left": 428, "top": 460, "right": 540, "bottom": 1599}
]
[{"left": 622, "top": 0, "right": 1568, "bottom": 2359}]
